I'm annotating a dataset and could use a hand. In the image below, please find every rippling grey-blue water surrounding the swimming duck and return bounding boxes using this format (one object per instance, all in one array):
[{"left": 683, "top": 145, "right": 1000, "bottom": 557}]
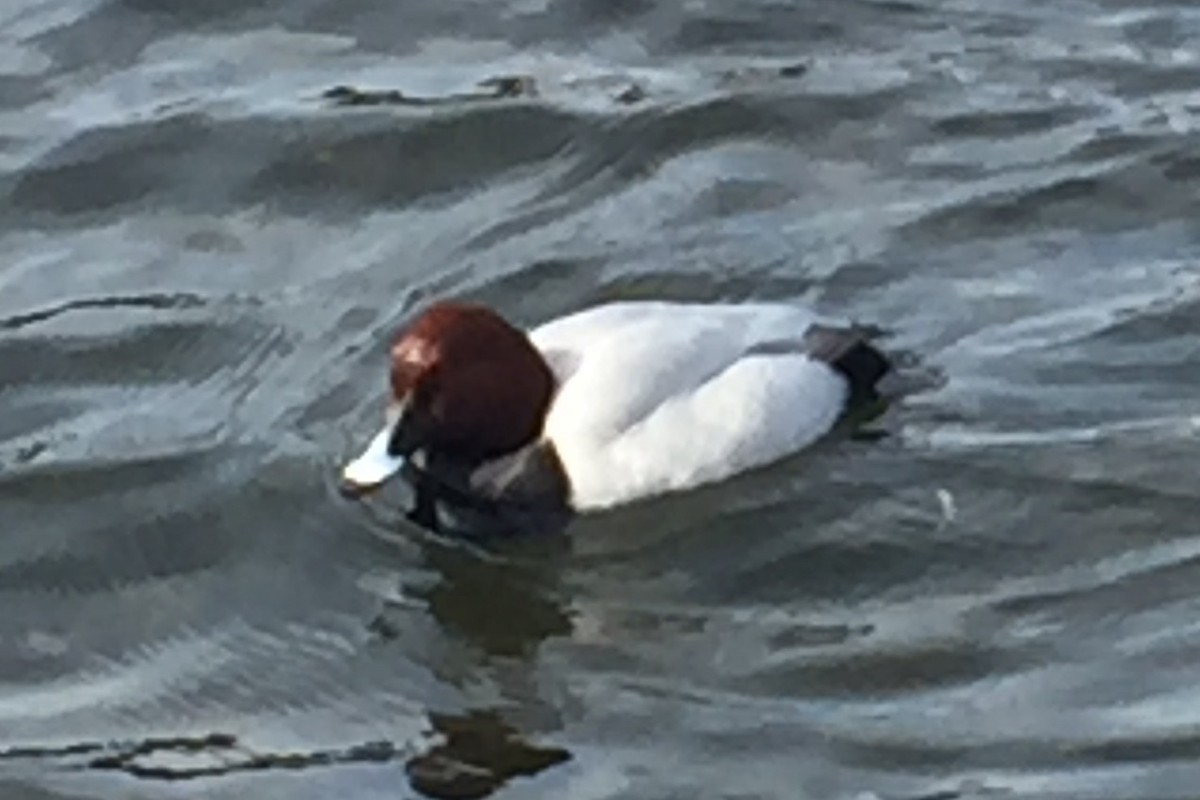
[{"left": 0, "top": 0, "right": 1200, "bottom": 800}]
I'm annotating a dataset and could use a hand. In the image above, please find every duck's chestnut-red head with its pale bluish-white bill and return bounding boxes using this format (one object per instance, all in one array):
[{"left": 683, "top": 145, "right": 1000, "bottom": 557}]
[{"left": 342, "top": 302, "right": 554, "bottom": 497}]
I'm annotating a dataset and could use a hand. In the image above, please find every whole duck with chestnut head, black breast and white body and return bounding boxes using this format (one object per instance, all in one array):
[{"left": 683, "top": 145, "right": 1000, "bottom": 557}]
[{"left": 341, "top": 300, "right": 892, "bottom": 527}]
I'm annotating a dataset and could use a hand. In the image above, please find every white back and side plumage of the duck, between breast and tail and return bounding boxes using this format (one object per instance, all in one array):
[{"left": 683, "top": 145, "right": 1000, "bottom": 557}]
[{"left": 530, "top": 302, "right": 864, "bottom": 510}]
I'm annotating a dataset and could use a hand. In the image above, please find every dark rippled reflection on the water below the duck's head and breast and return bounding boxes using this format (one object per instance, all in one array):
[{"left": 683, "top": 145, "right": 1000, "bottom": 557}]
[{"left": 368, "top": 525, "right": 572, "bottom": 799}]
